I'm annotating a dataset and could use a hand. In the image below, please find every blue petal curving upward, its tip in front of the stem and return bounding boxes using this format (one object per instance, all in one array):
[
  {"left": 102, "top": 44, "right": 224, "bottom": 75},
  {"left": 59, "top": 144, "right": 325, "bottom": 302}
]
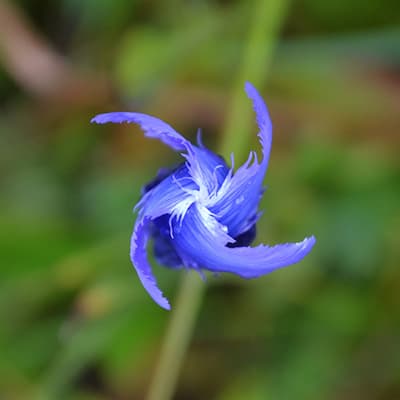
[{"left": 209, "top": 82, "right": 272, "bottom": 236}]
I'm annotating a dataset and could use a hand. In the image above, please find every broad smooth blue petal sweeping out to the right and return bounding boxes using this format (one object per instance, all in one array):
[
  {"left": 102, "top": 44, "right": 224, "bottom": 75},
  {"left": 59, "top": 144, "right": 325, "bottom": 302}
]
[{"left": 173, "top": 205, "right": 315, "bottom": 278}]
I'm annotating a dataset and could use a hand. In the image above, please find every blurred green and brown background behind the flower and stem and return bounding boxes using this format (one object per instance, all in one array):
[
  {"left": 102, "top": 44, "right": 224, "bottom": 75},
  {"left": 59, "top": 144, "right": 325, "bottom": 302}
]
[{"left": 0, "top": 0, "right": 400, "bottom": 400}]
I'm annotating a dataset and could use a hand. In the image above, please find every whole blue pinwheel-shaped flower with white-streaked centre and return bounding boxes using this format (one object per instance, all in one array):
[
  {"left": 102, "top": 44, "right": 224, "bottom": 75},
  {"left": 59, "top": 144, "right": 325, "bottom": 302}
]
[{"left": 92, "top": 83, "right": 315, "bottom": 310}]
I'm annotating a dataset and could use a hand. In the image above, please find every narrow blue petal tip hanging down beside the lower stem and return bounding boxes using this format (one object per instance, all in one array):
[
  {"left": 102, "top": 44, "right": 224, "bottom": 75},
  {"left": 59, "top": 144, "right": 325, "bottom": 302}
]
[{"left": 131, "top": 219, "right": 171, "bottom": 310}]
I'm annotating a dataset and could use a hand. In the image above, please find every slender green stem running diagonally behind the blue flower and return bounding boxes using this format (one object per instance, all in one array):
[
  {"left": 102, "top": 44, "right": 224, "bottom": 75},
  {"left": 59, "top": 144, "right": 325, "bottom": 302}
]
[{"left": 147, "top": 0, "right": 287, "bottom": 400}]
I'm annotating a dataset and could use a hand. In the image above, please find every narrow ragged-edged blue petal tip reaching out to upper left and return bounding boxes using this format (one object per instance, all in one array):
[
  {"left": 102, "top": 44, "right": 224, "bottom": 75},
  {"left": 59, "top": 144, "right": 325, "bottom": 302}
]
[{"left": 90, "top": 112, "right": 191, "bottom": 151}]
